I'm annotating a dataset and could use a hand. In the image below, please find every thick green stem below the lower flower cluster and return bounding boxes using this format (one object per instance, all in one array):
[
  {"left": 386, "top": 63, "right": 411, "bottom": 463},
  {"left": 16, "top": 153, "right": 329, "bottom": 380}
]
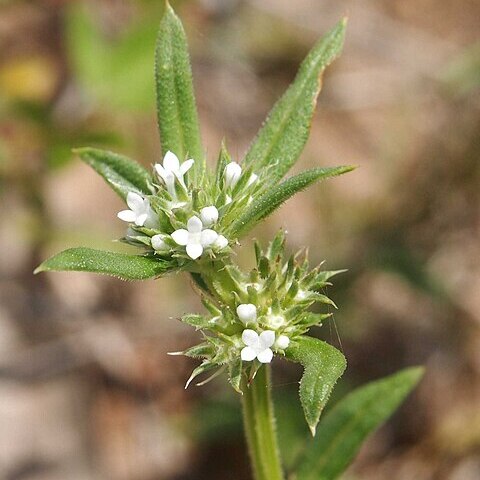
[{"left": 243, "top": 365, "right": 283, "bottom": 480}]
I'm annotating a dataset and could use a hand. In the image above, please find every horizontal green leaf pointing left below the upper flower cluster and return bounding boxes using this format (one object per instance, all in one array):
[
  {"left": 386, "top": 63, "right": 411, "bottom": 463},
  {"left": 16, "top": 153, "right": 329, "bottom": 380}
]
[{"left": 34, "top": 247, "right": 175, "bottom": 280}]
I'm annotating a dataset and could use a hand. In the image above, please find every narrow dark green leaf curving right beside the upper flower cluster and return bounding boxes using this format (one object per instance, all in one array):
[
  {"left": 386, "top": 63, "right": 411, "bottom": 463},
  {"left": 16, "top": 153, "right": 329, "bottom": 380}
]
[{"left": 230, "top": 166, "right": 355, "bottom": 236}]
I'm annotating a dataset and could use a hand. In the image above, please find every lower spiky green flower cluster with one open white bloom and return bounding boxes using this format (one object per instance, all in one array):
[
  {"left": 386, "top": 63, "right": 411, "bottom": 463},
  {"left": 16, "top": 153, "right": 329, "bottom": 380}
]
[{"left": 178, "top": 232, "right": 339, "bottom": 391}]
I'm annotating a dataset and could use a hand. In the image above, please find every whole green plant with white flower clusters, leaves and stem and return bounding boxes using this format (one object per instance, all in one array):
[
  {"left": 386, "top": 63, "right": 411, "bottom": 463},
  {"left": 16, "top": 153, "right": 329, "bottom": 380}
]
[{"left": 36, "top": 5, "right": 421, "bottom": 480}]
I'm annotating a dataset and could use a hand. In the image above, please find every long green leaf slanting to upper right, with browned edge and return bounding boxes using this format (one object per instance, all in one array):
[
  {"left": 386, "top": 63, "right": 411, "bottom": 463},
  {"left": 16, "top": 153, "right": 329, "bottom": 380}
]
[{"left": 244, "top": 19, "right": 346, "bottom": 184}]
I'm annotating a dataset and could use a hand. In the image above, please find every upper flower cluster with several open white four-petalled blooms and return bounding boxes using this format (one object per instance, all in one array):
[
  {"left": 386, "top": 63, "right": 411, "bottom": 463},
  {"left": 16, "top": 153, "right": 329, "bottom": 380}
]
[{"left": 118, "top": 152, "right": 258, "bottom": 264}]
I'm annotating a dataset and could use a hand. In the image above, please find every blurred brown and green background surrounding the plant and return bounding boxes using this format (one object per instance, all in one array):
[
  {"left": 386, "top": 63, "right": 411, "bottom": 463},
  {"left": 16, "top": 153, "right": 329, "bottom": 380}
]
[{"left": 0, "top": 0, "right": 480, "bottom": 480}]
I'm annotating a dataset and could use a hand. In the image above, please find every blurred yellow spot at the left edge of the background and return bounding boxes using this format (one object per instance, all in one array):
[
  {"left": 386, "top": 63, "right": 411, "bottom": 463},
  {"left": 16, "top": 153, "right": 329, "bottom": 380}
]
[{"left": 0, "top": 56, "right": 59, "bottom": 102}]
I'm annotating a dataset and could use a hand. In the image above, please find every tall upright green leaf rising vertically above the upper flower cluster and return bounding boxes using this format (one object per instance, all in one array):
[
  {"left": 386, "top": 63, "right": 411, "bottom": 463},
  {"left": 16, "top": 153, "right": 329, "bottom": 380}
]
[{"left": 155, "top": 3, "right": 205, "bottom": 179}]
